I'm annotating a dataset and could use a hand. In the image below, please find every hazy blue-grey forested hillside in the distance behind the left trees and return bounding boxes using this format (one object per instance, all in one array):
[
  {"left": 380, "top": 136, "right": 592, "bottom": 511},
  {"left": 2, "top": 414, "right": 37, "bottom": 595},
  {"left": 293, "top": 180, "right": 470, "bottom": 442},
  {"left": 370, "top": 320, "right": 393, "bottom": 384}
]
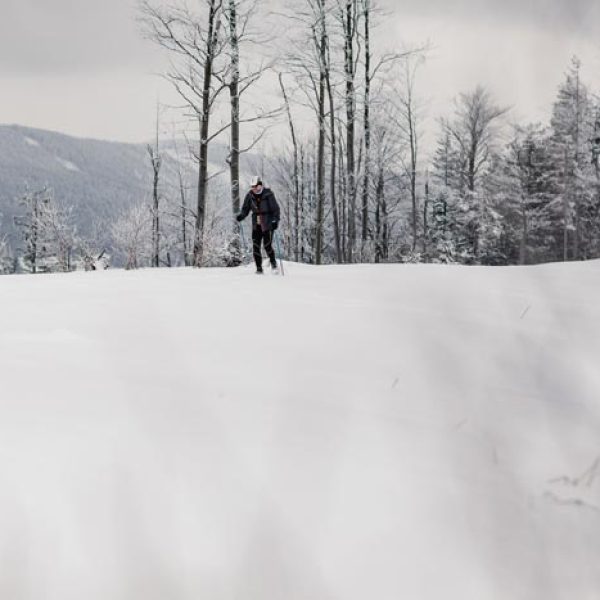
[{"left": 0, "top": 125, "right": 232, "bottom": 271}]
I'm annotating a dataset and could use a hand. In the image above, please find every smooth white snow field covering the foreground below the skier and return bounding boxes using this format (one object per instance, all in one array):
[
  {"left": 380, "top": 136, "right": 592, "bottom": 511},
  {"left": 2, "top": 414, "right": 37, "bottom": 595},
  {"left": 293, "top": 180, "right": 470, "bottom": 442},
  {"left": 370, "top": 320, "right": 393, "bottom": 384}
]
[{"left": 0, "top": 262, "right": 600, "bottom": 600}]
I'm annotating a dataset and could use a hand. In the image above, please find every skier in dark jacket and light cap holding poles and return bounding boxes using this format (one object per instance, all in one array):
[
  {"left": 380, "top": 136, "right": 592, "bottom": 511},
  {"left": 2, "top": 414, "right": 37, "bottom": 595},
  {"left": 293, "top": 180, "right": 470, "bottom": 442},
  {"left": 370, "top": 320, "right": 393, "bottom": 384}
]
[{"left": 236, "top": 177, "right": 280, "bottom": 273}]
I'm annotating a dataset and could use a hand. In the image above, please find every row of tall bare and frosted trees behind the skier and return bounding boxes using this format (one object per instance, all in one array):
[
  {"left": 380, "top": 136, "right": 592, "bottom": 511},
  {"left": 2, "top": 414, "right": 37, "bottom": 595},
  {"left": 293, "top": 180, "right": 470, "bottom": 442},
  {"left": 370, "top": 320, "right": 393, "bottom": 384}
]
[{"left": 2, "top": 0, "right": 600, "bottom": 270}]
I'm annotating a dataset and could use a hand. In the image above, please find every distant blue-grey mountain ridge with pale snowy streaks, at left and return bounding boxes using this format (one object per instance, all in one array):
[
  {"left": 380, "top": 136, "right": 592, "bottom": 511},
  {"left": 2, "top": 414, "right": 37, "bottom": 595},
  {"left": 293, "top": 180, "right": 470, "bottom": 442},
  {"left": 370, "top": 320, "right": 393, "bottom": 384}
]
[{"left": 0, "top": 124, "right": 228, "bottom": 253}]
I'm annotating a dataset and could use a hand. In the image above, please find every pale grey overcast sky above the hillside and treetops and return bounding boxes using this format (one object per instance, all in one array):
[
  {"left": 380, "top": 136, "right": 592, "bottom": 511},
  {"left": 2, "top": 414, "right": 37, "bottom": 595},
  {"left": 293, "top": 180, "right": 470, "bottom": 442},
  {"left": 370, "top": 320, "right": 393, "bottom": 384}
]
[{"left": 0, "top": 0, "right": 600, "bottom": 142}]
